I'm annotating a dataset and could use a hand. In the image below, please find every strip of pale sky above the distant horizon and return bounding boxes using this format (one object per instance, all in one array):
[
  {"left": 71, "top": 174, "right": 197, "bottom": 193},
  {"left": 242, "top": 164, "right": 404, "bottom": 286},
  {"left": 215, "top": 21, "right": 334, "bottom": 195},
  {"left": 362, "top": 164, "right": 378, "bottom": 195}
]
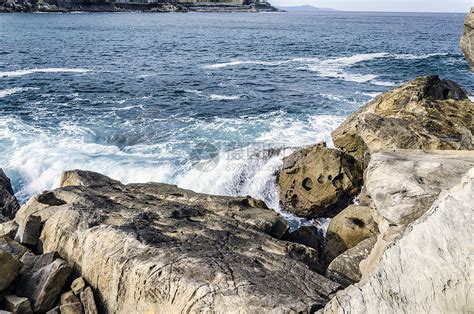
[{"left": 269, "top": 0, "right": 474, "bottom": 13}]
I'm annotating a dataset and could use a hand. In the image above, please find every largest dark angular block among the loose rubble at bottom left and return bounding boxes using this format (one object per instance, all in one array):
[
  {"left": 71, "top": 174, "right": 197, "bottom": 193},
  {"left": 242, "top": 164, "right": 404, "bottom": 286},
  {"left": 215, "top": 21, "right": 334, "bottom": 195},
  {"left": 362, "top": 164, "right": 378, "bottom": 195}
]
[{"left": 16, "top": 259, "right": 71, "bottom": 312}]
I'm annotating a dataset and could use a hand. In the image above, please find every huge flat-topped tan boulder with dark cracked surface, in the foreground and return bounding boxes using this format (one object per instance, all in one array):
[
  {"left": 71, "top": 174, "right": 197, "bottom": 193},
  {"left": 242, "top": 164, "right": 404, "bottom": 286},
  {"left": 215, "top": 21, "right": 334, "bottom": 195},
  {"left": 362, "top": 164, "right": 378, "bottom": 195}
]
[{"left": 16, "top": 171, "right": 340, "bottom": 313}]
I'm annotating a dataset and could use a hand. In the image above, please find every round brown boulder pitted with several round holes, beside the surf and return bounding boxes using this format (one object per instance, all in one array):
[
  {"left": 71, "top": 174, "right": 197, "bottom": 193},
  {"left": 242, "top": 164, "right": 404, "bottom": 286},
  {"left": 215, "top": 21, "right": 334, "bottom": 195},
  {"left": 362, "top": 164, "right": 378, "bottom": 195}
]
[{"left": 278, "top": 143, "right": 362, "bottom": 218}]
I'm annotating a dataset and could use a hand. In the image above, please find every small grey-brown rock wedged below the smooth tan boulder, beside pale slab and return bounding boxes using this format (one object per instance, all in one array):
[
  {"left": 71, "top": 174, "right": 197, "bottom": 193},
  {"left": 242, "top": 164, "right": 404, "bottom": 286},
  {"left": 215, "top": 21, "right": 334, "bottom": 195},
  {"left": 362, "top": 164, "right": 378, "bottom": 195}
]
[{"left": 326, "top": 237, "right": 377, "bottom": 287}]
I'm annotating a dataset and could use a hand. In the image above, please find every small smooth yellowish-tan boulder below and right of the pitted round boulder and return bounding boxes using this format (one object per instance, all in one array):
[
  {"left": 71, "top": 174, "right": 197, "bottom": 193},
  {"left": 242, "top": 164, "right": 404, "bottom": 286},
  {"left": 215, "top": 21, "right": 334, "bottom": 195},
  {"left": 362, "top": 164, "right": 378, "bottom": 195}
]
[{"left": 324, "top": 205, "right": 379, "bottom": 263}]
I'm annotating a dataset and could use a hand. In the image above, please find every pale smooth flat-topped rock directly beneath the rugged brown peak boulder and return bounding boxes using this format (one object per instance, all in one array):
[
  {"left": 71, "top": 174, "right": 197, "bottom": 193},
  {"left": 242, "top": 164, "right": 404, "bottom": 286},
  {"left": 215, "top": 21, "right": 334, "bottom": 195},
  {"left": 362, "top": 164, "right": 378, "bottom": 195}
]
[{"left": 365, "top": 150, "right": 474, "bottom": 225}]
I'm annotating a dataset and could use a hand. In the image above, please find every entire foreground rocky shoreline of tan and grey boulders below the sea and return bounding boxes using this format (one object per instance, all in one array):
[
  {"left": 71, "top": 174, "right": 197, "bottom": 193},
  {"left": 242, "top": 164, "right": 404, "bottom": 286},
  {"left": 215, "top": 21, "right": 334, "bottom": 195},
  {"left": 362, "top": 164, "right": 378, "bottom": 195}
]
[{"left": 0, "top": 8, "right": 474, "bottom": 313}]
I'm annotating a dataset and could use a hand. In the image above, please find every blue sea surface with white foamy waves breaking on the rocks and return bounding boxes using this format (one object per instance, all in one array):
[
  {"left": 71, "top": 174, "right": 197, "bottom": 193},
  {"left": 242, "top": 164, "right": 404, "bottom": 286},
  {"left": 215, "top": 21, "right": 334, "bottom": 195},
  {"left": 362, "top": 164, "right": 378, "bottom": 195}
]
[{"left": 0, "top": 12, "right": 474, "bottom": 226}]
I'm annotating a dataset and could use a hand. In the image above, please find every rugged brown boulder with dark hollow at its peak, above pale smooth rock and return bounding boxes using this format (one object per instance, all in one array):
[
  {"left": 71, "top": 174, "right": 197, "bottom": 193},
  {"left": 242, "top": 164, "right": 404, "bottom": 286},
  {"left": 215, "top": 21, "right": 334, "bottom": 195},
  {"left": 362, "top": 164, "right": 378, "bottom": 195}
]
[{"left": 332, "top": 76, "right": 474, "bottom": 160}]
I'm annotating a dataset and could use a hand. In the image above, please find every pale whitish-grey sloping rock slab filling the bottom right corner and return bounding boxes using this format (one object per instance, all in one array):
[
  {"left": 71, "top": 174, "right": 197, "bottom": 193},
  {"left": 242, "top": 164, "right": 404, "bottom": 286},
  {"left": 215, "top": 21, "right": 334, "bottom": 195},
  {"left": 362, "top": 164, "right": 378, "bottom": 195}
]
[{"left": 324, "top": 169, "right": 474, "bottom": 313}]
